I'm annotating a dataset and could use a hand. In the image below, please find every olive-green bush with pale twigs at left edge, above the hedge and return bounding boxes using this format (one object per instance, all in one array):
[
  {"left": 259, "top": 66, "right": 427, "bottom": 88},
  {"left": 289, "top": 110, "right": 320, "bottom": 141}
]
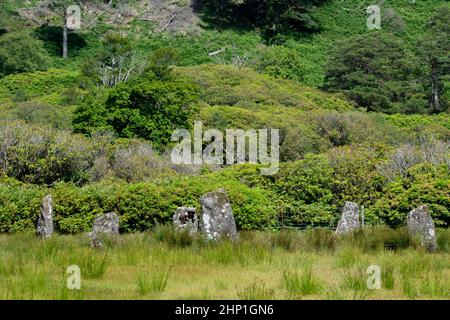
[{"left": 0, "top": 122, "right": 92, "bottom": 184}]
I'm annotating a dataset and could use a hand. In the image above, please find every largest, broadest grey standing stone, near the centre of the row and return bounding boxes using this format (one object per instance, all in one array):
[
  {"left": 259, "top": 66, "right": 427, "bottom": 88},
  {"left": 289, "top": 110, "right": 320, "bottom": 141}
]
[{"left": 200, "top": 189, "right": 238, "bottom": 240}]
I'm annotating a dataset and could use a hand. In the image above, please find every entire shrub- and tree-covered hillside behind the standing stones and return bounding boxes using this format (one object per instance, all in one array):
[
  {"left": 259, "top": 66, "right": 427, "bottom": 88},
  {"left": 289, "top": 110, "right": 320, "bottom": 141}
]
[{"left": 0, "top": 0, "right": 450, "bottom": 233}]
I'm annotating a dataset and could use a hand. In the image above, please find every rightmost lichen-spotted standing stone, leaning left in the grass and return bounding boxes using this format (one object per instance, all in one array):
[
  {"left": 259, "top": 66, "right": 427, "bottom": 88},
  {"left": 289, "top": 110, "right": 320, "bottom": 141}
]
[{"left": 406, "top": 205, "right": 437, "bottom": 251}]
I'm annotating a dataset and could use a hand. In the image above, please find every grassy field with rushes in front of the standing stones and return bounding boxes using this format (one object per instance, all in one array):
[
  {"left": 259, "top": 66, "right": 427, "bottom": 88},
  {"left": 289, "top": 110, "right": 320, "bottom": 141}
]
[{"left": 0, "top": 227, "right": 450, "bottom": 299}]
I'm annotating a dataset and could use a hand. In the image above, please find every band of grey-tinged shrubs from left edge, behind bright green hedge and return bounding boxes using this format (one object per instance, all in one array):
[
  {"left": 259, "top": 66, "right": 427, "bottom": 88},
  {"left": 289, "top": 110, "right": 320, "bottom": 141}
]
[{"left": 0, "top": 121, "right": 180, "bottom": 184}]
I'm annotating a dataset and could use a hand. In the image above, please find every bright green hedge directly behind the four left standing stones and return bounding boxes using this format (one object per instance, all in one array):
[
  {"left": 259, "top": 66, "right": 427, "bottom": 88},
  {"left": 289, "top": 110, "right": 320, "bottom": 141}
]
[{"left": 0, "top": 174, "right": 276, "bottom": 233}]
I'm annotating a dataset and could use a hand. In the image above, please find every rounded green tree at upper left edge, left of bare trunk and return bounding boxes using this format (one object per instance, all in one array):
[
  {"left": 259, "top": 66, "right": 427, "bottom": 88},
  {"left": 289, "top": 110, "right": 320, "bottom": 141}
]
[{"left": 0, "top": 33, "right": 50, "bottom": 77}]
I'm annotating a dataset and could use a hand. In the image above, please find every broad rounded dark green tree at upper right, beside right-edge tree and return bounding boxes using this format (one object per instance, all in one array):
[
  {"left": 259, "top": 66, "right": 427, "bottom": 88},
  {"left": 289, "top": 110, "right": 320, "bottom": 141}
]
[{"left": 324, "top": 31, "right": 427, "bottom": 113}]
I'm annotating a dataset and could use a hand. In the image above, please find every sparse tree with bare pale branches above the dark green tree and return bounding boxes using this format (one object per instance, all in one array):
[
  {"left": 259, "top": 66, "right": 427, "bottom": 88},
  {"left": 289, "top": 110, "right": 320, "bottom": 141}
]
[{"left": 82, "top": 33, "right": 147, "bottom": 88}]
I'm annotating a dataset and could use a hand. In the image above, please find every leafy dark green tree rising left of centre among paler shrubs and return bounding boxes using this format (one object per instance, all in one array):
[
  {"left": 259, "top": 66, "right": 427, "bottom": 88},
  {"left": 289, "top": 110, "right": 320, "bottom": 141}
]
[{"left": 73, "top": 76, "right": 198, "bottom": 148}]
